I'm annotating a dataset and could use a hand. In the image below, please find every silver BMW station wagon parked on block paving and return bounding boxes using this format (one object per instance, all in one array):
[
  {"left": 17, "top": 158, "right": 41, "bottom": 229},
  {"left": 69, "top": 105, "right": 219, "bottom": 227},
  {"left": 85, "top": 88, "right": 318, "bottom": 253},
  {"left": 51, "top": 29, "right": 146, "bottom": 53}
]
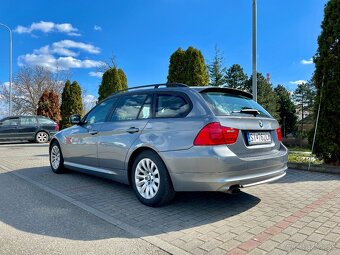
[{"left": 49, "top": 83, "right": 287, "bottom": 206}]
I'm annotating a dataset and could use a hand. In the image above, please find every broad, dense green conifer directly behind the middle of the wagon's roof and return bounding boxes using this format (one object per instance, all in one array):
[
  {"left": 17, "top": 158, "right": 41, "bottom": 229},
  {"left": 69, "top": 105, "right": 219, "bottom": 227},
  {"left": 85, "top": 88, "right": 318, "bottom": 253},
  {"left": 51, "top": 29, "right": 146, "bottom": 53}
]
[{"left": 168, "top": 46, "right": 209, "bottom": 86}]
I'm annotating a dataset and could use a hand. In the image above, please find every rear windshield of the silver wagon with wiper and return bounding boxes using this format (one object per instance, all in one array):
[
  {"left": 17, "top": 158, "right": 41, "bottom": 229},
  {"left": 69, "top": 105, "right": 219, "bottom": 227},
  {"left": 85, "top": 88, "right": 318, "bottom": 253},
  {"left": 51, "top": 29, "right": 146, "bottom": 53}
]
[{"left": 201, "top": 92, "right": 272, "bottom": 118}]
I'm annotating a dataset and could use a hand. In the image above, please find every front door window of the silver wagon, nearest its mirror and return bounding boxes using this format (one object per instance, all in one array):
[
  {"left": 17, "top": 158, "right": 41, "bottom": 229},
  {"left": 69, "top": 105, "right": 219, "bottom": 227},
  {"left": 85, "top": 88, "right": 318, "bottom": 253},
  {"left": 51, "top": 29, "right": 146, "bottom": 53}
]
[{"left": 84, "top": 98, "right": 117, "bottom": 124}]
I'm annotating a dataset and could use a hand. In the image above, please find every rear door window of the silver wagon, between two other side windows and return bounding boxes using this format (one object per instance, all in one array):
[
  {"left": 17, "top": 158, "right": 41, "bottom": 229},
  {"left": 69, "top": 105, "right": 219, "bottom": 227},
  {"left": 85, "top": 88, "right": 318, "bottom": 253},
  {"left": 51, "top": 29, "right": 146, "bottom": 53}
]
[{"left": 111, "top": 95, "right": 147, "bottom": 121}]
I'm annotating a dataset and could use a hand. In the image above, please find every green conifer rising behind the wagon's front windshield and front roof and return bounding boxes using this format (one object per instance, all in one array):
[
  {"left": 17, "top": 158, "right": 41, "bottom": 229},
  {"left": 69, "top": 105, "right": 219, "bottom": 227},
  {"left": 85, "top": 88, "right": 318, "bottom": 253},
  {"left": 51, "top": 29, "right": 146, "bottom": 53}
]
[{"left": 98, "top": 66, "right": 122, "bottom": 101}]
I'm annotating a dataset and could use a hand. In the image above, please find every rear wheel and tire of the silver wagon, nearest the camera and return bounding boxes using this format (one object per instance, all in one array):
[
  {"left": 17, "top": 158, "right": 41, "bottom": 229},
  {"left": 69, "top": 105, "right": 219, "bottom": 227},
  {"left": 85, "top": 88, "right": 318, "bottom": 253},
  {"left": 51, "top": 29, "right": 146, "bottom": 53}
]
[{"left": 131, "top": 151, "right": 176, "bottom": 207}]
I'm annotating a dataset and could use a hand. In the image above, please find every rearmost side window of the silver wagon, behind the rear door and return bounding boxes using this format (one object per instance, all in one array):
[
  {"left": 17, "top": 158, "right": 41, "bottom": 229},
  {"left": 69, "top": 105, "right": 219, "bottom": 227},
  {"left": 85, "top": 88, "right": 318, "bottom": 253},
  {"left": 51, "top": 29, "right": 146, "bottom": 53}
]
[{"left": 156, "top": 94, "right": 190, "bottom": 118}]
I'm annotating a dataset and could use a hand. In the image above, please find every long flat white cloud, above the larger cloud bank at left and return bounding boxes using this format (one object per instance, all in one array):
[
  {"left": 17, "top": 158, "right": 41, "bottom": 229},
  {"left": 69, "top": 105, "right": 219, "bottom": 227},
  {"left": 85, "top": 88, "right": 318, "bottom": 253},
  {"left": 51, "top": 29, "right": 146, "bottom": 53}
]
[{"left": 14, "top": 21, "right": 81, "bottom": 36}]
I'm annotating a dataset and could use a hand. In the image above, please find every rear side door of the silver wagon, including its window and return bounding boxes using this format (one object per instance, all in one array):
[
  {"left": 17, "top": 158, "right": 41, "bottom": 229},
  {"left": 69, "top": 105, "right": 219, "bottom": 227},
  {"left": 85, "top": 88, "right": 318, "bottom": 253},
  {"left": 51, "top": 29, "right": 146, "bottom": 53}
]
[{"left": 98, "top": 93, "right": 152, "bottom": 174}]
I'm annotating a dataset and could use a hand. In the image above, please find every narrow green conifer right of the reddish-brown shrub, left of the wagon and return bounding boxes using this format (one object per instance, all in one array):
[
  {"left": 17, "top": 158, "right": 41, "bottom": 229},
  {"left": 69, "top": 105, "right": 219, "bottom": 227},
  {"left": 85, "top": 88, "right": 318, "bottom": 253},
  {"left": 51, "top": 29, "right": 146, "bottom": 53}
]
[{"left": 60, "top": 81, "right": 83, "bottom": 128}]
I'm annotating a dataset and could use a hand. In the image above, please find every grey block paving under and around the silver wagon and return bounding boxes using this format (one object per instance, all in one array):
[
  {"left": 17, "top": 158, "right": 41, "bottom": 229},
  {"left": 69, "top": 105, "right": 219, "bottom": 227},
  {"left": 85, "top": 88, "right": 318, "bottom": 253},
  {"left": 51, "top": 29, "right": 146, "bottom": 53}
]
[{"left": 0, "top": 143, "right": 340, "bottom": 255}]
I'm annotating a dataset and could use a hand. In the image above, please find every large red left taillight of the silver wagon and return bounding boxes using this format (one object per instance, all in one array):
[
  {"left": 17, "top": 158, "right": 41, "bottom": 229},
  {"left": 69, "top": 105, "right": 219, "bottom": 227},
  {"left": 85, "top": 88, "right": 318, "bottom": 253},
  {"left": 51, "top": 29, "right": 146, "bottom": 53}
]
[{"left": 194, "top": 122, "right": 238, "bottom": 146}]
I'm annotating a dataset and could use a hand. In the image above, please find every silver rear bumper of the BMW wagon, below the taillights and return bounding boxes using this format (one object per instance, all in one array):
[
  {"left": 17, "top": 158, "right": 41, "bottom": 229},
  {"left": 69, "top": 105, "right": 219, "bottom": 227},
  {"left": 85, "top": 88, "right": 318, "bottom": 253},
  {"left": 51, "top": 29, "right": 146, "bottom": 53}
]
[{"left": 161, "top": 142, "right": 288, "bottom": 191}]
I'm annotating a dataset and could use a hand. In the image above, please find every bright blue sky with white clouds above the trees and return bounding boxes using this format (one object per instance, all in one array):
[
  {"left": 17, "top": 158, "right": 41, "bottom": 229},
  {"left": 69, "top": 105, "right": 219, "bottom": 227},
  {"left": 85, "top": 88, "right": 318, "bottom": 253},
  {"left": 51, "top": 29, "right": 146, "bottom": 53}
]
[{"left": 0, "top": 0, "right": 327, "bottom": 99}]
